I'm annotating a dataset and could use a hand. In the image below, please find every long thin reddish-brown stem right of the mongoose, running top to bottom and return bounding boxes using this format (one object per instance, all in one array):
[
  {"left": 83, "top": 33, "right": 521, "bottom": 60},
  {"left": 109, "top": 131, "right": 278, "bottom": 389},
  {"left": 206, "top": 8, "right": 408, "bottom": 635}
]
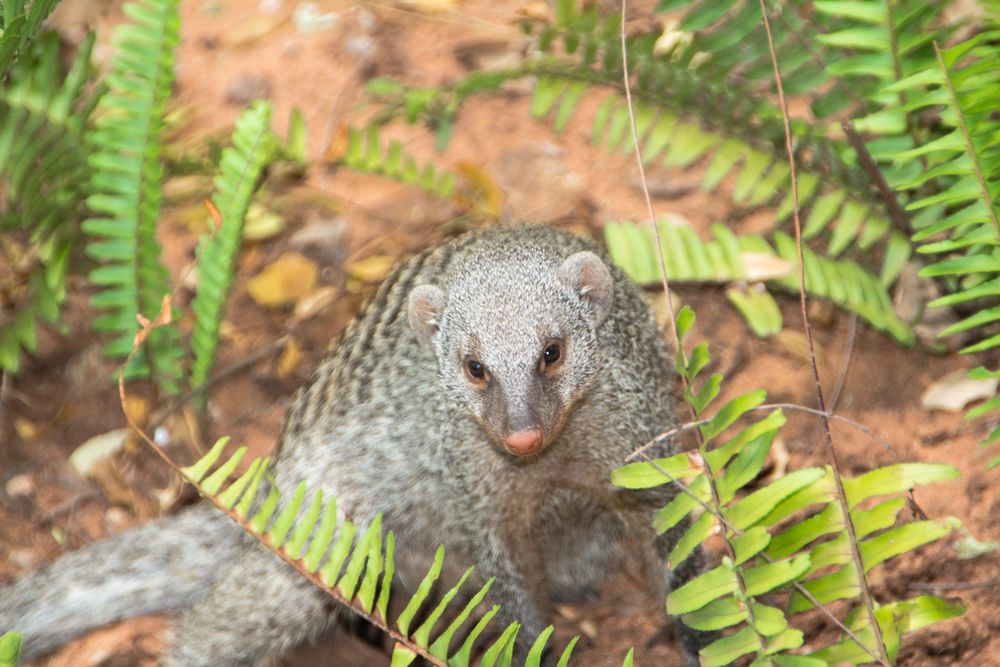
[{"left": 760, "top": 0, "right": 889, "bottom": 667}]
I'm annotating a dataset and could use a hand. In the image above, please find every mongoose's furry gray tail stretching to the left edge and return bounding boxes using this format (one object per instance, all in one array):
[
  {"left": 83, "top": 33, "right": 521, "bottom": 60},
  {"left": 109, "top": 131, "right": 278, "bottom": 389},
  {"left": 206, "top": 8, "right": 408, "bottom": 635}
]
[{"left": 0, "top": 506, "right": 244, "bottom": 659}]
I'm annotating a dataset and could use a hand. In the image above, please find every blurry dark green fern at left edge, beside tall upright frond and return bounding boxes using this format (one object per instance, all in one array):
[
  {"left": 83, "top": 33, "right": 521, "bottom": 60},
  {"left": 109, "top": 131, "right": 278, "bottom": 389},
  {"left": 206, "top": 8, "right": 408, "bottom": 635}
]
[{"left": 0, "top": 33, "right": 94, "bottom": 373}]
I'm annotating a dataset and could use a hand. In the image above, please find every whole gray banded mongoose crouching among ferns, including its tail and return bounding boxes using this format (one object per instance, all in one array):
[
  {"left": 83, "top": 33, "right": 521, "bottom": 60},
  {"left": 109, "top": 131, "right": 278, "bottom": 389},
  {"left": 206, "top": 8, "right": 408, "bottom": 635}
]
[{"left": 0, "top": 226, "right": 706, "bottom": 666}]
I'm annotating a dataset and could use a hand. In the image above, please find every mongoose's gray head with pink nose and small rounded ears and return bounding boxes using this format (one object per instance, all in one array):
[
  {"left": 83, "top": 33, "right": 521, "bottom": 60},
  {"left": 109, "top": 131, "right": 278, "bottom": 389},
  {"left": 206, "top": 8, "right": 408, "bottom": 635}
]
[{"left": 408, "top": 249, "right": 614, "bottom": 456}]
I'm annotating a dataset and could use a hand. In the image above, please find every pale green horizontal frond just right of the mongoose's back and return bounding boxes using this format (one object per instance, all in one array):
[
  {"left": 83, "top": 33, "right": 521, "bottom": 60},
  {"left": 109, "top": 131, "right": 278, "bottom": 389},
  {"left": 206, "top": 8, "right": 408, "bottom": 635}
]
[{"left": 604, "top": 220, "right": 914, "bottom": 345}]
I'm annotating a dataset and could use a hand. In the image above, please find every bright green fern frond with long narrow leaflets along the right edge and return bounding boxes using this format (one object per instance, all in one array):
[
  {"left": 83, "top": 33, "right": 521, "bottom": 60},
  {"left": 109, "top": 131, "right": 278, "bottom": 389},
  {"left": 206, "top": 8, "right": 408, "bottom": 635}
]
[{"left": 886, "top": 30, "right": 1000, "bottom": 460}]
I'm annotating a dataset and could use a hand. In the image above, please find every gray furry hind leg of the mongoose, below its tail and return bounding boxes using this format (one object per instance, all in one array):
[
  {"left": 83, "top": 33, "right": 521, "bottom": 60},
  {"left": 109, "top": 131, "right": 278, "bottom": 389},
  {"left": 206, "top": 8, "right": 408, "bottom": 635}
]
[{"left": 166, "top": 547, "right": 337, "bottom": 667}]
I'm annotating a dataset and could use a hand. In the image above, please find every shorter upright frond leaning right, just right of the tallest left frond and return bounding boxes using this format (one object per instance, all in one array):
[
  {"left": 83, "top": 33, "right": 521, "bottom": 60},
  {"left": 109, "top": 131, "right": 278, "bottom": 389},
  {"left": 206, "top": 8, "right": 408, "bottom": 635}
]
[{"left": 190, "top": 102, "right": 277, "bottom": 400}]
